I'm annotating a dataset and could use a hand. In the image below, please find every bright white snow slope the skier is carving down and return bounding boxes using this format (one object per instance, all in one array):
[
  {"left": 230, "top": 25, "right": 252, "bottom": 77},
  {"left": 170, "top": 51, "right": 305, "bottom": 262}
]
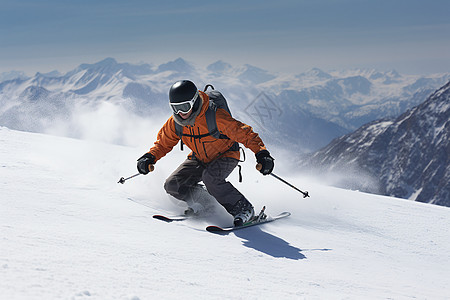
[{"left": 0, "top": 127, "right": 450, "bottom": 300}]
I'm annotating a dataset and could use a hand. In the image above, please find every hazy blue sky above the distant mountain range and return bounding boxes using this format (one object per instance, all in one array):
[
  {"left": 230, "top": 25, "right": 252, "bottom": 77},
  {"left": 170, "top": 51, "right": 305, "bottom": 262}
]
[{"left": 0, "top": 0, "right": 450, "bottom": 75}]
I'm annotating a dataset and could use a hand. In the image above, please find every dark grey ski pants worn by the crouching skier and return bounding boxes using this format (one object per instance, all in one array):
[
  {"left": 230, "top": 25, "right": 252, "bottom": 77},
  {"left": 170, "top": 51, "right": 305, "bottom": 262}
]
[{"left": 164, "top": 157, "right": 245, "bottom": 212}]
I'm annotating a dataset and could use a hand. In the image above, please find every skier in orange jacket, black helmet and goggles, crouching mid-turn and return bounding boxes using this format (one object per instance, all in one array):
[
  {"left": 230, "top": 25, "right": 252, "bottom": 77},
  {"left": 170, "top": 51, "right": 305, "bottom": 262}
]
[{"left": 137, "top": 80, "right": 274, "bottom": 226}]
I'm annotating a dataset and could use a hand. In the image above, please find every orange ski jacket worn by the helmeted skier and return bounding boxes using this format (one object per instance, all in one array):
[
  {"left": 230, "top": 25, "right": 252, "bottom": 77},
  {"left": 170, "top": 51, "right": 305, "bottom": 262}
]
[{"left": 149, "top": 91, "right": 266, "bottom": 163}]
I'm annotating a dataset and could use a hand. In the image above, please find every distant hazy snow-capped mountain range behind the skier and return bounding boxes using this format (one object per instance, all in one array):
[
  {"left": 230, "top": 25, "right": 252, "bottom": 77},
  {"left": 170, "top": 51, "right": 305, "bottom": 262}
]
[{"left": 0, "top": 58, "right": 450, "bottom": 153}]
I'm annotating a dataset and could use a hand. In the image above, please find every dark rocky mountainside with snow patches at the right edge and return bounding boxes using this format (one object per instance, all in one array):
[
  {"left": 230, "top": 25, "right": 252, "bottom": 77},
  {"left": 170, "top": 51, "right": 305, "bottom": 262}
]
[{"left": 301, "top": 82, "right": 450, "bottom": 206}]
